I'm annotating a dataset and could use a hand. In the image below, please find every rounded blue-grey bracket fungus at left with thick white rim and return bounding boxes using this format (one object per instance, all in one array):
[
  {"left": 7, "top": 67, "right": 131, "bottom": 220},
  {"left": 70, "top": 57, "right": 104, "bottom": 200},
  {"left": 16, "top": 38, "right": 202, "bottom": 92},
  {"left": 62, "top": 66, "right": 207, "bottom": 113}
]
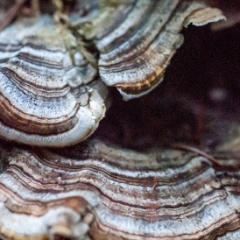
[{"left": 0, "top": 16, "right": 106, "bottom": 147}]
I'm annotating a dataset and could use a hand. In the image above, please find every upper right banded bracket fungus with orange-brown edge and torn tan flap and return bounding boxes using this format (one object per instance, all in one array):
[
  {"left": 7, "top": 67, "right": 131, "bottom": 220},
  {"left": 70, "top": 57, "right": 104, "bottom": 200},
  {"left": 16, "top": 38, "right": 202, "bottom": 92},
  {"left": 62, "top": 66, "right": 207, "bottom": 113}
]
[{"left": 83, "top": 0, "right": 225, "bottom": 100}]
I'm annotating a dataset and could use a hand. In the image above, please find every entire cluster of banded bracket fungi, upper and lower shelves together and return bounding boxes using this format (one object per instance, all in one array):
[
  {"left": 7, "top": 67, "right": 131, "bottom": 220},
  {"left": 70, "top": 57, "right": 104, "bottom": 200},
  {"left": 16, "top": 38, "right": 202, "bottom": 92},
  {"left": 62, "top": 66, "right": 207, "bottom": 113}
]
[{"left": 0, "top": 0, "right": 240, "bottom": 240}]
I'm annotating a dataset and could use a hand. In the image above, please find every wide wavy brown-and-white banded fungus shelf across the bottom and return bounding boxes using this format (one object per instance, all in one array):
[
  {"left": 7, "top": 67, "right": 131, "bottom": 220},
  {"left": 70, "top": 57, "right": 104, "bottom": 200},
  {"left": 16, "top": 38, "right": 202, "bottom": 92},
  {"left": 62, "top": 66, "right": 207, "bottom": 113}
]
[{"left": 0, "top": 140, "right": 240, "bottom": 240}]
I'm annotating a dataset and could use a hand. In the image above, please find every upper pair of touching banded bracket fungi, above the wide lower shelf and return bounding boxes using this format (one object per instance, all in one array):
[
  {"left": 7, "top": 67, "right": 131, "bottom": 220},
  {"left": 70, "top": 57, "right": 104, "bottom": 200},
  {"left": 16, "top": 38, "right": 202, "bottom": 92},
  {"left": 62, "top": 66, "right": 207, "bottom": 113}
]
[{"left": 0, "top": 0, "right": 225, "bottom": 147}]
